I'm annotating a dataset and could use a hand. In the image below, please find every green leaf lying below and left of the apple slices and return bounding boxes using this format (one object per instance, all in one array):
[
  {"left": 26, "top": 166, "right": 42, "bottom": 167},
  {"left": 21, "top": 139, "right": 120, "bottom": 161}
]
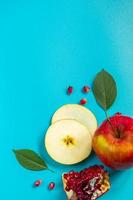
[{"left": 13, "top": 149, "right": 48, "bottom": 171}]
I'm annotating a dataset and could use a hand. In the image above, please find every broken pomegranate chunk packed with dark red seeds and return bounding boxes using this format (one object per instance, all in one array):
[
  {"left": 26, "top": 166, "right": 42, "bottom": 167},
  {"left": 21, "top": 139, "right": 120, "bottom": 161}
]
[{"left": 63, "top": 165, "right": 110, "bottom": 200}]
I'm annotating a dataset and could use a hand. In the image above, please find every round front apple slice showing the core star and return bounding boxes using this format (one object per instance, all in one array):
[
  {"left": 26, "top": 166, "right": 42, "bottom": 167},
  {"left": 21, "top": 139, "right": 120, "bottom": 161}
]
[{"left": 45, "top": 120, "right": 92, "bottom": 165}]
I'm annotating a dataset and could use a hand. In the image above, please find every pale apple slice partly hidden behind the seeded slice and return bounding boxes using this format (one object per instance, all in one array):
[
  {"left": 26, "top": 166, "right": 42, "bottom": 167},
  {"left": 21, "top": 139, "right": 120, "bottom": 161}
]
[{"left": 52, "top": 104, "right": 97, "bottom": 136}]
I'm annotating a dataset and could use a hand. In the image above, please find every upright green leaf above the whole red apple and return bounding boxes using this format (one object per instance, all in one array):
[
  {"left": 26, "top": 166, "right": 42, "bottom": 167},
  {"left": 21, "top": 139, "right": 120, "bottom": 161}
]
[{"left": 93, "top": 70, "right": 117, "bottom": 111}]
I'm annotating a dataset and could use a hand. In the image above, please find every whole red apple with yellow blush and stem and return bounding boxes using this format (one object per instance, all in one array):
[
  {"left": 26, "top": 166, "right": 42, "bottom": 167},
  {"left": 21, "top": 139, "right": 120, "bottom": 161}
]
[{"left": 92, "top": 114, "right": 133, "bottom": 170}]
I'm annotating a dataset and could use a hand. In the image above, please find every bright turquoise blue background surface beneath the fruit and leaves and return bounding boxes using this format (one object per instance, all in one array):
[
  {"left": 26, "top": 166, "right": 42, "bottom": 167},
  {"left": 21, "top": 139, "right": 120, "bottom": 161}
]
[{"left": 0, "top": 0, "right": 133, "bottom": 200}]
